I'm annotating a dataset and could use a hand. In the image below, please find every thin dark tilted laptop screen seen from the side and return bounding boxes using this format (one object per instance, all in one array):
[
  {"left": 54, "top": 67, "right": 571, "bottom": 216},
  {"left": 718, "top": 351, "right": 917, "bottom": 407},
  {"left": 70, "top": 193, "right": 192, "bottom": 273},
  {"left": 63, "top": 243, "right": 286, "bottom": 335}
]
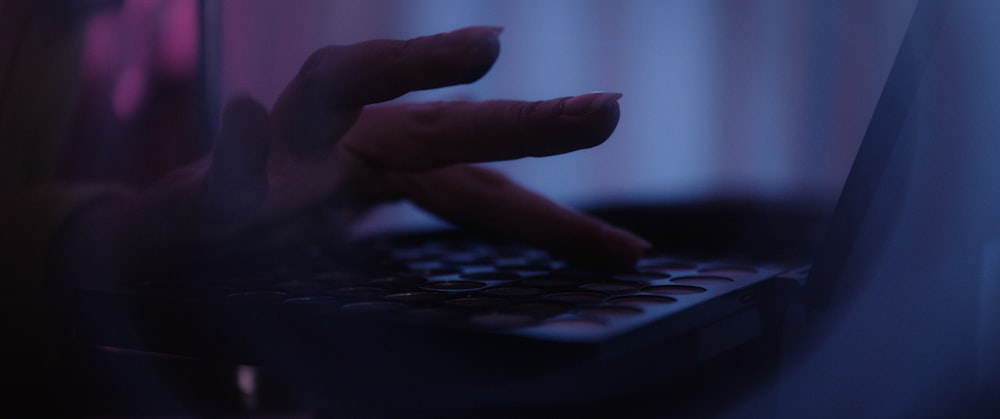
[{"left": 806, "top": 1, "right": 947, "bottom": 307}]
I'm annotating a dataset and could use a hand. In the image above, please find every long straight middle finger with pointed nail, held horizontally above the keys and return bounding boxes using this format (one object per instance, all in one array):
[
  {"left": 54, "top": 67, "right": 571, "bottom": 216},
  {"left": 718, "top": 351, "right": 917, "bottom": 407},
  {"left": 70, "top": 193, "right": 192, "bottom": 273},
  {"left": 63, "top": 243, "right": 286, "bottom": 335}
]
[{"left": 340, "top": 93, "right": 621, "bottom": 170}]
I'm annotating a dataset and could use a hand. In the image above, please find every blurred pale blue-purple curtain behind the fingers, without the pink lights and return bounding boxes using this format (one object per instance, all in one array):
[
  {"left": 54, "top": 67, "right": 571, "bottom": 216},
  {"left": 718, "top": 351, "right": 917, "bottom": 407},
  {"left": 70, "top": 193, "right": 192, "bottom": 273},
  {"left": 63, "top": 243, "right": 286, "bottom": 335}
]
[{"left": 220, "top": 0, "right": 915, "bottom": 231}]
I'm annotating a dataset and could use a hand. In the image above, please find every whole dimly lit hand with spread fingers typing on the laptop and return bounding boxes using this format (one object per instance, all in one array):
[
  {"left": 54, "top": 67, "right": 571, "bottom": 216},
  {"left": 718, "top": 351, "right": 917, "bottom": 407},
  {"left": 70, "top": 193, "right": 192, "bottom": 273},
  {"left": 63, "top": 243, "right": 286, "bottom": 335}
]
[{"left": 61, "top": 27, "right": 648, "bottom": 286}]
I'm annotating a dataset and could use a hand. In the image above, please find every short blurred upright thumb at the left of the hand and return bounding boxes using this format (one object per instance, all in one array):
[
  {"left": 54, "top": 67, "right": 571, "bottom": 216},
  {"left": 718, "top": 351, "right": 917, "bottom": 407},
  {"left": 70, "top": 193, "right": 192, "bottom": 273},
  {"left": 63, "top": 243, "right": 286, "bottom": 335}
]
[{"left": 205, "top": 97, "right": 270, "bottom": 220}]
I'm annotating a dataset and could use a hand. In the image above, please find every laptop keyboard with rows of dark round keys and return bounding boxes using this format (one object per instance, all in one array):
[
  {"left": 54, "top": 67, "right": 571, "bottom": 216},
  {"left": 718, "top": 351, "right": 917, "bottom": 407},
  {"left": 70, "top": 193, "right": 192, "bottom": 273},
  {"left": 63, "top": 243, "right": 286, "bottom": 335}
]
[{"left": 135, "top": 237, "right": 781, "bottom": 342}]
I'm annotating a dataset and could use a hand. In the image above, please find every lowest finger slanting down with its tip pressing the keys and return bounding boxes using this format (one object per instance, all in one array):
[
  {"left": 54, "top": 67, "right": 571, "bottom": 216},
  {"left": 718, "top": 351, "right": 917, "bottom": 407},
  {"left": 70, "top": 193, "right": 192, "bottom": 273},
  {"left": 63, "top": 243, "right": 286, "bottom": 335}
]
[{"left": 395, "top": 166, "right": 650, "bottom": 268}]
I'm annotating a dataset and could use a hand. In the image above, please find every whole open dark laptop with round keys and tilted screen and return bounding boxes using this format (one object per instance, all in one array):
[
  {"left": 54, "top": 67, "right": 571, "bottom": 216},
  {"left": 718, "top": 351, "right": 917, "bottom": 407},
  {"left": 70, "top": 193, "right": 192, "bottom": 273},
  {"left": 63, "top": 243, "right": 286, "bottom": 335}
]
[{"left": 74, "top": 0, "right": 992, "bottom": 414}]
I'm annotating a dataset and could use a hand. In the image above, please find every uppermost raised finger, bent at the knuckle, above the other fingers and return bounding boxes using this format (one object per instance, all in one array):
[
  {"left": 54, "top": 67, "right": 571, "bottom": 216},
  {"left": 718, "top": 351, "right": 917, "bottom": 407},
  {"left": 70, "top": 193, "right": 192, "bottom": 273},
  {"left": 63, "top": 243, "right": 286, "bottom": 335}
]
[{"left": 273, "top": 27, "right": 500, "bottom": 154}]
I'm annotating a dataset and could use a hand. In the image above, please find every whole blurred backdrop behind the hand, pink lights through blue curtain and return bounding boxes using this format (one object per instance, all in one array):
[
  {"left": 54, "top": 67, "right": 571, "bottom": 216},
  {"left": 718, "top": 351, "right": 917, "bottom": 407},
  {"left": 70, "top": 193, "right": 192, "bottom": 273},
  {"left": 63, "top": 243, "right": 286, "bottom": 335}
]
[{"left": 67, "top": 0, "right": 915, "bottom": 229}]
